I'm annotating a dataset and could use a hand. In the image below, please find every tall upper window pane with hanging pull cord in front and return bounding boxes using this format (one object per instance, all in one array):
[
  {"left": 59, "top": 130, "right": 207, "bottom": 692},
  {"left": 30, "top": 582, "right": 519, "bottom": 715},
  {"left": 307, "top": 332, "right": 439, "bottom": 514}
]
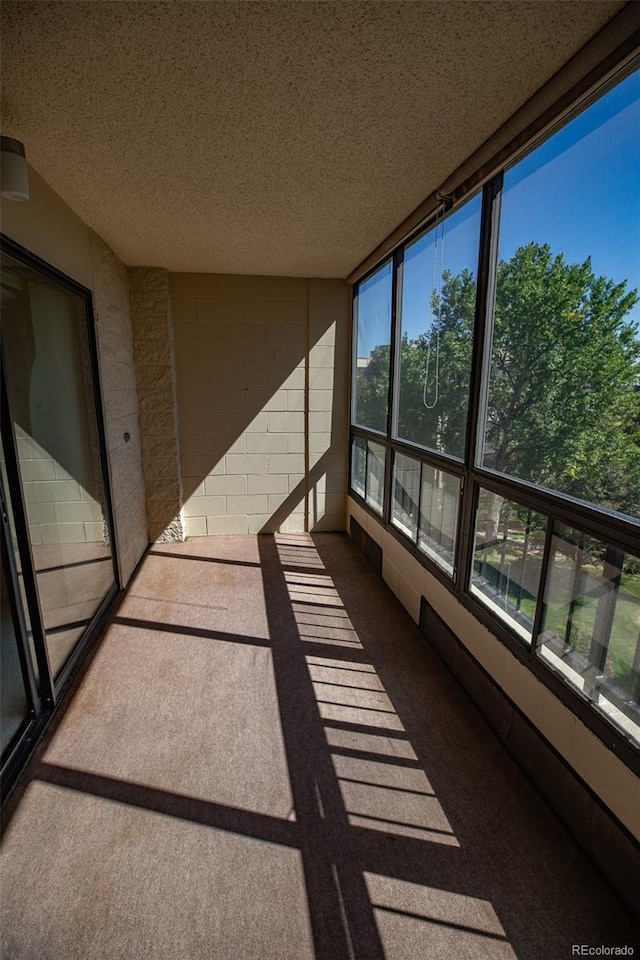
[{"left": 397, "top": 195, "right": 481, "bottom": 458}]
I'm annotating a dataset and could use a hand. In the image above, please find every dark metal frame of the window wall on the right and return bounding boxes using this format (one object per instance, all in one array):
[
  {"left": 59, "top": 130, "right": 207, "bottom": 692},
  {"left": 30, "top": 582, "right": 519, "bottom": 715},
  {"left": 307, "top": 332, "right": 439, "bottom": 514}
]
[{"left": 348, "top": 56, "right": 640, "bottom": 775}]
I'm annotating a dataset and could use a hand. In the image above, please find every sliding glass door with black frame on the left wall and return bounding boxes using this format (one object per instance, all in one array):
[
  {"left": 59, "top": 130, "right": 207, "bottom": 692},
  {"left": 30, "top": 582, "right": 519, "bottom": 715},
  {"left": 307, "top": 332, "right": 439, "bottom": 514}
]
[{"left": 2, "top": 242, "right": 117, "bottom": 788}]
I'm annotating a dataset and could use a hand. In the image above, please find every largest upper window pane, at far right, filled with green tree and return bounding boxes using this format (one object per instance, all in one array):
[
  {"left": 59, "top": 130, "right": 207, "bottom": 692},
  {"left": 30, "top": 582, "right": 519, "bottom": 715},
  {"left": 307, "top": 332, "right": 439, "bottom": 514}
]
[{"left": 482, "top": 72, "right": 640, "bottom": 517}]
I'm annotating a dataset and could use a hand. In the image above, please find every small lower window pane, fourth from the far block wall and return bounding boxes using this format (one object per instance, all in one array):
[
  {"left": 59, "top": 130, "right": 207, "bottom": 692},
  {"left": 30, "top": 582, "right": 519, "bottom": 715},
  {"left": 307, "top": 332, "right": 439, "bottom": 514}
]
[{"left": 418, "top": 463, "right": 460, "bottom": 576}]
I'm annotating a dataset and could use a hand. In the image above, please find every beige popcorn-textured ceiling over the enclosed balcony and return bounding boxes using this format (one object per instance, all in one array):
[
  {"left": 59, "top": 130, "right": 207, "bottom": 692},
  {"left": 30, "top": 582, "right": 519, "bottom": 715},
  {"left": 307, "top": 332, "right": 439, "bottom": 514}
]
[{"left": 1, "top": 0, "right": 624, "bottom": 277}]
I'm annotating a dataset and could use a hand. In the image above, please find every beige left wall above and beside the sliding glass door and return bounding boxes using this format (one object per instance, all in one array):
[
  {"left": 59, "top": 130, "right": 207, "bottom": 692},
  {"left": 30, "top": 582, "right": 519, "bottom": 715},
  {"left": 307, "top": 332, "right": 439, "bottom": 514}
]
[{"left": 1, "top": 169, "right": 148, "bottom": 586}]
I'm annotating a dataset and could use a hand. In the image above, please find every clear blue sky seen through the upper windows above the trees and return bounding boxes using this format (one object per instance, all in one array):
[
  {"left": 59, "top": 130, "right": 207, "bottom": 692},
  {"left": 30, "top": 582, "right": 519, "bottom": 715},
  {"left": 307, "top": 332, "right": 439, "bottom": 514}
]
[{"left": 358, "top": 70, "right": 640, "bottom": 356}]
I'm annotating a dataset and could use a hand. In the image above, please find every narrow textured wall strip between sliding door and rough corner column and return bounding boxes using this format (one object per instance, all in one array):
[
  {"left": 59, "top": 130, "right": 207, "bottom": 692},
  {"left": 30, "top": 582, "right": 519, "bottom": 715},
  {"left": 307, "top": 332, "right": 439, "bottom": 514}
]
[{"left": 89, "top": 231, "right": 148, "bottom": 587}]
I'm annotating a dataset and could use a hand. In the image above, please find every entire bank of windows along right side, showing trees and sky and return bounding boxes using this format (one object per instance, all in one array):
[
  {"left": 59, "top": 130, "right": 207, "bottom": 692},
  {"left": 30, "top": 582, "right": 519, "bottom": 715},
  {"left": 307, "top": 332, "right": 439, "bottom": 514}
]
[{"left": 351, "top": 62, "right": 640, "bottom": 762}]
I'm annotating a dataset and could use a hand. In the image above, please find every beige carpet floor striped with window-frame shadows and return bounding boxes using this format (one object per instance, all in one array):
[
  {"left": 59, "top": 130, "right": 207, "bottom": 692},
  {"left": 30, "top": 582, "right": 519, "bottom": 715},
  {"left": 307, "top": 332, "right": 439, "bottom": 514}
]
[{"left": 1, "top": 534, "right": 640, "bottom": 960}]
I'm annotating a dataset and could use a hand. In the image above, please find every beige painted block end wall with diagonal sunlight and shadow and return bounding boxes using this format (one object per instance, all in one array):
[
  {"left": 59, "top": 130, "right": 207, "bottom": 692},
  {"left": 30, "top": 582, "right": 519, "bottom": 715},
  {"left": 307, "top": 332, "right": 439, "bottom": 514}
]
[{"left": 170, "top": 274, "right": 350, "bottom": 536}]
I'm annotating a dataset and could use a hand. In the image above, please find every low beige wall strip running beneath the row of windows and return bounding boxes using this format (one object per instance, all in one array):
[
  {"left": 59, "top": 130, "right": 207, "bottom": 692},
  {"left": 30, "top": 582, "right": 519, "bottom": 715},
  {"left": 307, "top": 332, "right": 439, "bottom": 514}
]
[{"left": 348, "top": 497, "right": 640, "bottom": 839}]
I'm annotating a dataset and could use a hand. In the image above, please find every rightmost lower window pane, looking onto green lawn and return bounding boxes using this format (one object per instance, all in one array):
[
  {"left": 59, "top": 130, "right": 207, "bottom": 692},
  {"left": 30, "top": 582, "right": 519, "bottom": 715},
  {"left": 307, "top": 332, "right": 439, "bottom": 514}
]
[{"left": 539, "top": 527, "right": 640, "bottom": 742}]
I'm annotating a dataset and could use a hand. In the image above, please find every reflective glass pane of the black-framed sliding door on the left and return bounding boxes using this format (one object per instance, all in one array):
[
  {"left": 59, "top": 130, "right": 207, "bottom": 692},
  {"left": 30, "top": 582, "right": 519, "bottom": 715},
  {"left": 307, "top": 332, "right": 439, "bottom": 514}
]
[{"left": 2, "top": 255, "right": 114, "bottom": 674}]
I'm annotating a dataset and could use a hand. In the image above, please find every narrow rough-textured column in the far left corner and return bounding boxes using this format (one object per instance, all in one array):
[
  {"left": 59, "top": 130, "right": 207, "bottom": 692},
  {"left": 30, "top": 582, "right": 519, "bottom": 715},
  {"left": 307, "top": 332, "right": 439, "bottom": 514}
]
[{"left": 129, "top": 267, "right": 184, "bottom": 543}]
